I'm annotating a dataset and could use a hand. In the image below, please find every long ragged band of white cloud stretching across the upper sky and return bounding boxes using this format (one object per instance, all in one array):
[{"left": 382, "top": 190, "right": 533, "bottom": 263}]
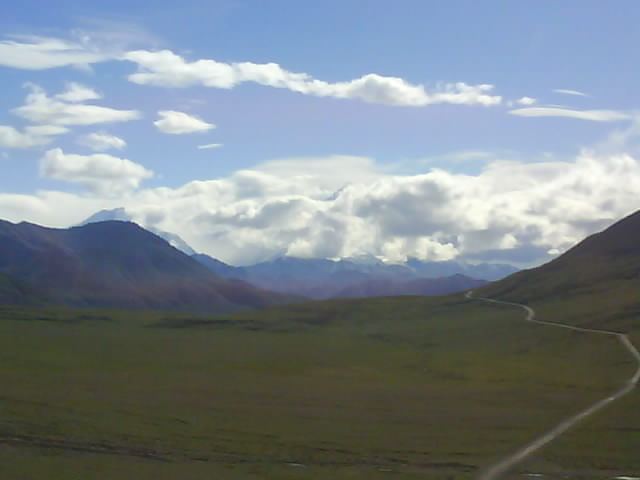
[{"left": 123, "top": 50, "right": 502, "bottom": 106}]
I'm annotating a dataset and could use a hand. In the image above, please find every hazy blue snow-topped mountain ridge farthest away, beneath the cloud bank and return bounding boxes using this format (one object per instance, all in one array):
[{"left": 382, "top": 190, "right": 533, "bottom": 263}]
[{"left": 80, "top": 208, "right": 517, "bottom": 299}]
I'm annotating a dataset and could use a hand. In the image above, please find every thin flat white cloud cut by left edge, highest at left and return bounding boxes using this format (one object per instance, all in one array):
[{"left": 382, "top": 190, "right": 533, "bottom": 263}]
[{"left": 0, "top": 35, "right": 109, "bottom": 70}]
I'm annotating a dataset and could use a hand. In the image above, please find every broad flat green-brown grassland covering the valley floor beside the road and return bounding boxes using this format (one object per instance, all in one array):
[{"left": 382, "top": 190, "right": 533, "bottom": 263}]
[{"left": 0, "top": 296, "right": 640, "bottom": 480}]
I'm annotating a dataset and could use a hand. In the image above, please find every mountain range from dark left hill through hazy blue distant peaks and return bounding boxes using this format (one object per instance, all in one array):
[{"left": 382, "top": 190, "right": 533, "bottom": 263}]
[{"left": 0, "top": 218, "right": 486, "bottom": 312}]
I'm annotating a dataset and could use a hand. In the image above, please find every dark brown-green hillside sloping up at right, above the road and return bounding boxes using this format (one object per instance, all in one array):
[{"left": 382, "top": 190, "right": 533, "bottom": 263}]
[{"left": 478, "top": 212, "right": 640, "bottom": 331}]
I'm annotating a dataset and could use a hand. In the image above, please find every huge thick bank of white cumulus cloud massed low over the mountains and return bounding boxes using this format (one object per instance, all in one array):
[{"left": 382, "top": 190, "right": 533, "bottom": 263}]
[{"left": 5, "top": 144, "right": 640, "bottom": 264}]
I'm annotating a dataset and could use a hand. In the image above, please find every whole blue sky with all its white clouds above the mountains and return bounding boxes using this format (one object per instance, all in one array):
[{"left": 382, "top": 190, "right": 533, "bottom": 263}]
[{"left": 0, "top": 0, "right": 640, "bottom": 266}]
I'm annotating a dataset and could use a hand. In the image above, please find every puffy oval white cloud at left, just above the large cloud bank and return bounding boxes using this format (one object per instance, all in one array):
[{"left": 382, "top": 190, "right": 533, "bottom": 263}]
[{"left": 40, "top": 148, "right": 153, "bottom": 195}]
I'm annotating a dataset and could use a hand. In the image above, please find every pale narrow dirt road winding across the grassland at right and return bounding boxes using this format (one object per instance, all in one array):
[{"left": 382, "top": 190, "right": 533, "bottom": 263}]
[{"left": 465, "top": 290, "right": 640, "bottom": 480}]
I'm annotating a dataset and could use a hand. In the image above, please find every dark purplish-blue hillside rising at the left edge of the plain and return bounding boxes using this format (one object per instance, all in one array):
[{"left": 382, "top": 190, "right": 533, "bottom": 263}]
[{"left": 0, "top": 221, "right": 285, "bottom": 312}]
